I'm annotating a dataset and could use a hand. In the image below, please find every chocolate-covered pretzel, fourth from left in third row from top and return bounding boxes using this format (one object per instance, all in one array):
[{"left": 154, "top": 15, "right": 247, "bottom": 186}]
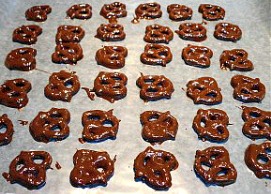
[{"left": 140, "top": 44, "right": 172, "bottom": 67}]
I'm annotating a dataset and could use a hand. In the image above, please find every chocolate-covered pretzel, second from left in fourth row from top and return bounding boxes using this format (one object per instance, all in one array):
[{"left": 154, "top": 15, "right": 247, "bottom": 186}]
[{"left": 44, "top": 70, "right": 80, "bottom": 102}]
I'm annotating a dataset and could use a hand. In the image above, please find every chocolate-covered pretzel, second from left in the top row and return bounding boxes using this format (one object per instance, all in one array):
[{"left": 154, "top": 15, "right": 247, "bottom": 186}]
[{"left": 66, "top": 4, "right": 92, "bottom": 20}]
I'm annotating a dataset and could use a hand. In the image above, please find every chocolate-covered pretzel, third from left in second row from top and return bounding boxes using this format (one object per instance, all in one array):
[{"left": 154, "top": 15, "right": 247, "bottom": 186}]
[{"left": 95, "top": 23, "right": 126, "bottom": 41}]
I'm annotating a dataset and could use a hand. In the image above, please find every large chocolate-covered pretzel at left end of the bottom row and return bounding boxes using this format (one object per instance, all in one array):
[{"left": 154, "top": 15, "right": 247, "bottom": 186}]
[{"left": 3, "top": 151, "right": 52, "bottom": 189}]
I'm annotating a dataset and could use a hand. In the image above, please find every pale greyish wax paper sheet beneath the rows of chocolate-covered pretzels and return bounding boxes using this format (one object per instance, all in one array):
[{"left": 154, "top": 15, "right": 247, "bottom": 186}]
[{"left": 0, "top": 0, "right": 271, "bottom": 194}]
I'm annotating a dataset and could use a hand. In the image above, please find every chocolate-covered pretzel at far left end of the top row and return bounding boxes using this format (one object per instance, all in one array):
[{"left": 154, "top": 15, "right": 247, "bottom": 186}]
[{"left": 25, "top": 5, "right": 52, "bottom": 22}]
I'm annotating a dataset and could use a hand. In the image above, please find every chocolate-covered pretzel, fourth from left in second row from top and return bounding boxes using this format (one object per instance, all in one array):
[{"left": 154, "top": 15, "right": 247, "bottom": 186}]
[{"left": 144, "top": 24, "right": 173, "bottom": 44}]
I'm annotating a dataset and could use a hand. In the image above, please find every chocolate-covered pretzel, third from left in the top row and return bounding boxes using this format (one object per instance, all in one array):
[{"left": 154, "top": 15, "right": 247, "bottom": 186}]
[{"left": 100, "top": 2, "right": 127, "bottom": 19}]
